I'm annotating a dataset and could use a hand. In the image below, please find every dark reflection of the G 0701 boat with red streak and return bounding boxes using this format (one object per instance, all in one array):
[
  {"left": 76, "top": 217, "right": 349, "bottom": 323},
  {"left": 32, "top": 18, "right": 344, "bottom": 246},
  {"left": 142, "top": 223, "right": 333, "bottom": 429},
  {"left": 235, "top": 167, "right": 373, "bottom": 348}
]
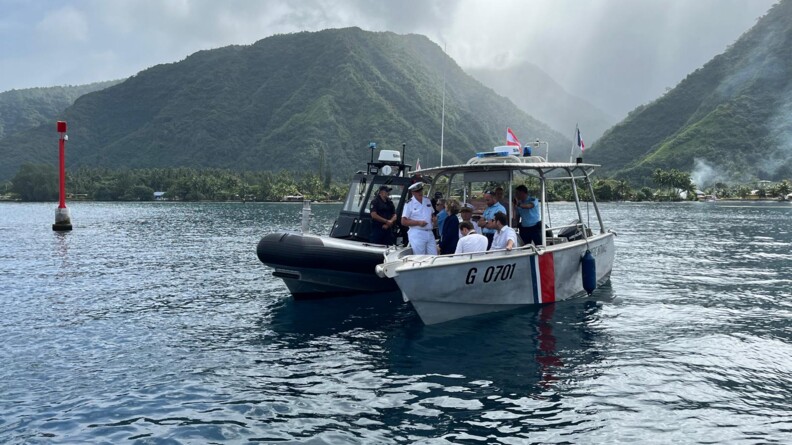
[{"left": 386, "top": 285, "right": 610, "bottom": 395}]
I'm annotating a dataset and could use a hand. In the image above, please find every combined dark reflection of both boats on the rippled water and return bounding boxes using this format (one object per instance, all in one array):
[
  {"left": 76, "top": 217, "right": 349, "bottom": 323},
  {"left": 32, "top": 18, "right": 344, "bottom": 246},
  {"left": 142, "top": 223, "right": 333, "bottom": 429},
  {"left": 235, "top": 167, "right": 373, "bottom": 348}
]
[{"left": 262, "top": 285, "right": 613, "bottom": 394}]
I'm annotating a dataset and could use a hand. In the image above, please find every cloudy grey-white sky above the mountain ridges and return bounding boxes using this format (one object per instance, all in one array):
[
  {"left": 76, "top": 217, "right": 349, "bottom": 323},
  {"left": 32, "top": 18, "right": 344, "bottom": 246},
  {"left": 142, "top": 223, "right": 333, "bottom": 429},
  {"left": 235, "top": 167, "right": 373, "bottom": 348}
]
[{"left": 0, "top": 0, "right": 776, "bottom": 117}]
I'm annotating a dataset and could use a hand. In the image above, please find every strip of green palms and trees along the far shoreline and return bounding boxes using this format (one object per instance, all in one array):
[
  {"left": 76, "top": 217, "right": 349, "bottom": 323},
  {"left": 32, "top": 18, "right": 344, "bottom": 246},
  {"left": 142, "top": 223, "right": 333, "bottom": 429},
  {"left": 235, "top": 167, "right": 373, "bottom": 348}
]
[{"left": 0, "top": 164, "right": 792, "bottom": 202}]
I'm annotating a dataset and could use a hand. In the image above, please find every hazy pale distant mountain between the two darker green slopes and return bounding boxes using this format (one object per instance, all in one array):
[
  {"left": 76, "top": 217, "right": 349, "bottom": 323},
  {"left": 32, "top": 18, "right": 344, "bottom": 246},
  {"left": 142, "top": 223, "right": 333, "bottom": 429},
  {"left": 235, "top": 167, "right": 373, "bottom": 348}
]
[{"left": 467, "top": 62, "right": 616, "bottom": 141}]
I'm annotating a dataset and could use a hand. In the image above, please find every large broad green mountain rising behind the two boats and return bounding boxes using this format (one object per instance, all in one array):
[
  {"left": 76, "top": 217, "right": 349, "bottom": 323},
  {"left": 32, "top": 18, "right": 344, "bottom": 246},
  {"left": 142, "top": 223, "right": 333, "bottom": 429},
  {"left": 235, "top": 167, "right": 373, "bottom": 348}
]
[{"left": 0, "top": 28, "right": 571, "bottom": 179}]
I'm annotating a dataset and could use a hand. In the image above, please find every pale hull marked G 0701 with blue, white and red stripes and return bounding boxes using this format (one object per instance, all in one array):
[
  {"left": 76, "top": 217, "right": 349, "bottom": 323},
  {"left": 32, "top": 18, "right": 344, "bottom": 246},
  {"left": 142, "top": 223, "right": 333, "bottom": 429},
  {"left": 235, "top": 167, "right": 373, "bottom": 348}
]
[{"left": 378, "top": 233, "right": 614, "bottom": 324}]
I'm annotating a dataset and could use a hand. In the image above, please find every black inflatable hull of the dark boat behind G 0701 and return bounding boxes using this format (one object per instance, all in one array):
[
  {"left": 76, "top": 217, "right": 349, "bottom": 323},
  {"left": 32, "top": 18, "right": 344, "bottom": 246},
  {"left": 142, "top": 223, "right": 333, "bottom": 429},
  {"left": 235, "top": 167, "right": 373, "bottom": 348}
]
[{"left": 256, "top": 232, "right": 398, "bottom": 299}]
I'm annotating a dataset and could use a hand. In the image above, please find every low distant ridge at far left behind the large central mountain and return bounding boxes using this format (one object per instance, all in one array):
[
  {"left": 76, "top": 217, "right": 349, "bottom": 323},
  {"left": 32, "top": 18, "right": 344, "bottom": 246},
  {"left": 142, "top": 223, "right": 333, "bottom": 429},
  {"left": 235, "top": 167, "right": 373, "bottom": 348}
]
[{"left": 0, "top": 80, "right": 121, "bottom": 139}]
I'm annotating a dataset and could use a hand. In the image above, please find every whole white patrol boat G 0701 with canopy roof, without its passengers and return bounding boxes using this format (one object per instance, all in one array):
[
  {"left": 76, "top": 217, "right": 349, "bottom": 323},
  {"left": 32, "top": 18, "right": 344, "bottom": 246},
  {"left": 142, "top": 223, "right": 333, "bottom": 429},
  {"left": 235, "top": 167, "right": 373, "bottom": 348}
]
[{"left": 376, "top": 147, "right": 615, "bottom": 324}]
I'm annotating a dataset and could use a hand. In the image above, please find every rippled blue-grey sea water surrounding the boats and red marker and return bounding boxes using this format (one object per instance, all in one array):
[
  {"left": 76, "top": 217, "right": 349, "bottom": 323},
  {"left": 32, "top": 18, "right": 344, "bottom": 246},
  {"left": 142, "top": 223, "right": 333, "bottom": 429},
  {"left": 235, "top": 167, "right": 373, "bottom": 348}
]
[{"left": 0, "top": 199, "right": 792, "bottom": 444}]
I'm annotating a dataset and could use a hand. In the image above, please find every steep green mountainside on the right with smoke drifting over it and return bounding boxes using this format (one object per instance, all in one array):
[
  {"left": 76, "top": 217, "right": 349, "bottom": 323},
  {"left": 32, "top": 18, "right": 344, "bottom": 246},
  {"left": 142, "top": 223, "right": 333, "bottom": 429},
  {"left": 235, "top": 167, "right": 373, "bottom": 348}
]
[{"left": 586, "top": 0, "right": 792, "bottom": 187}]
